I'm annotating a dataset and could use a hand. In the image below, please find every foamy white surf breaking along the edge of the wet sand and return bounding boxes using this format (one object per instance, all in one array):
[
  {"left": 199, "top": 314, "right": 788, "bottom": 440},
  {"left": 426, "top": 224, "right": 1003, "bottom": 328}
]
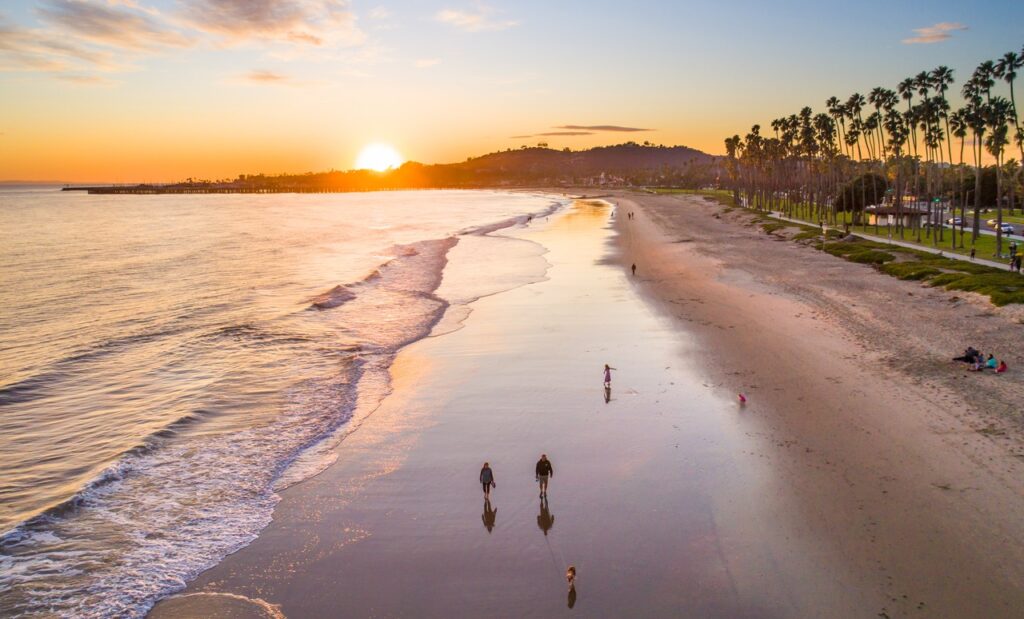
[{"left": 0, "top": 195, "right": 573, "bottom": 618}]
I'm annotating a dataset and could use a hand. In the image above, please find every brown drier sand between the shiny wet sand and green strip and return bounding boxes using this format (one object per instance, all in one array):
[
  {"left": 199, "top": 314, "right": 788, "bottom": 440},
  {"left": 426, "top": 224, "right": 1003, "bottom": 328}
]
[{"left": 616, "top": 193, "right": 1024, "bottom": 617}]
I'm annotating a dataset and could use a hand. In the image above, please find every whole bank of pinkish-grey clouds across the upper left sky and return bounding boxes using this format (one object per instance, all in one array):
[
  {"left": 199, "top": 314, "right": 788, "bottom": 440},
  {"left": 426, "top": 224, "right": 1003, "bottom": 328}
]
[{"left": 0, "top": 0, "right": 367, "bottom": 84}]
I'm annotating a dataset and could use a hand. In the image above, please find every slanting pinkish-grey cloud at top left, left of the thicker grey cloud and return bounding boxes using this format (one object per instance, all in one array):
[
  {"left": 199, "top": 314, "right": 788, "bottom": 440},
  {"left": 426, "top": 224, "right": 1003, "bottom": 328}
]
[{"left": 36, "top": 0, "right": 191, "bottom": 50}]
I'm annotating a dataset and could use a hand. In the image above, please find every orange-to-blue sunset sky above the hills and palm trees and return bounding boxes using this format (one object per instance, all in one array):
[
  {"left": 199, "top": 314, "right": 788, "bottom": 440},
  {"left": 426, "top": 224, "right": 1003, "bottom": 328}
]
[{"left": 0, "top": 0, "right": 1024, "bottom": 182}]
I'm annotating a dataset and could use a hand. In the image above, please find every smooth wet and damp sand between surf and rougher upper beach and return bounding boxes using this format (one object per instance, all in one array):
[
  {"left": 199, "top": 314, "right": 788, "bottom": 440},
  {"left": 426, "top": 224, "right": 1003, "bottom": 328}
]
[{"left": 152, "top": 196, "right": 1024, "bottom": 618}]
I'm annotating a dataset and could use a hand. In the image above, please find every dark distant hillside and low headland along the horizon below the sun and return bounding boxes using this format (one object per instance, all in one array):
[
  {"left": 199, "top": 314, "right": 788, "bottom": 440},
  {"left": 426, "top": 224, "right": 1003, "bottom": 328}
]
[{"left": 70, "top": 142, "right": 719, "bottom": 193}]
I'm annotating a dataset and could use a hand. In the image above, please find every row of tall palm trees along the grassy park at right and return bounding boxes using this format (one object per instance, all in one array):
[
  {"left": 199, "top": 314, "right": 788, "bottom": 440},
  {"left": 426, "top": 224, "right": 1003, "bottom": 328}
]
[{"left": 725, "top": 47, "right": 1024, "bottom": 254}]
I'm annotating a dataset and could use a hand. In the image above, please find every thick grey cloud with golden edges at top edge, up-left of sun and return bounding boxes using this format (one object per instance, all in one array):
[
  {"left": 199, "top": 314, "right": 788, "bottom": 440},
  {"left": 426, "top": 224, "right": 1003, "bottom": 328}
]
[{"left": 180, "top": 0, "right": 366, "bottom": 46}]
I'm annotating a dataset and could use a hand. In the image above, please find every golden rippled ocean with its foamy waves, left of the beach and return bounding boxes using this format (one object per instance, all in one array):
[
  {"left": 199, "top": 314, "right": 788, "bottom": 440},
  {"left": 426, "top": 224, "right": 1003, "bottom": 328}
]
[{"left": 0, "top": 189, "right": 565, "bottom": 617}]
